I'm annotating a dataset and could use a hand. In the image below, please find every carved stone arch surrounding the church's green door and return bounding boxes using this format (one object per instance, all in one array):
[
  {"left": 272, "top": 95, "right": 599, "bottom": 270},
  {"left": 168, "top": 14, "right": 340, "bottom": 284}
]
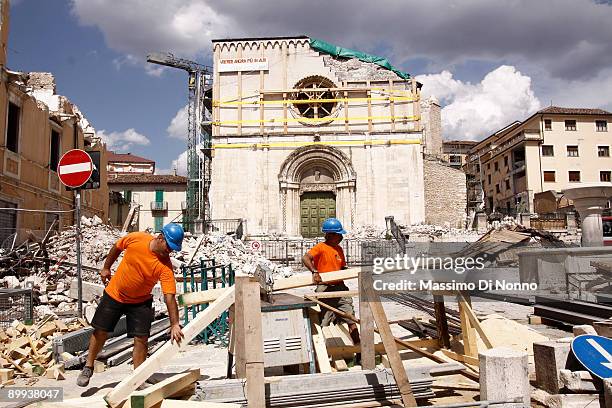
[{"left": 278, "top": 145, "right": 357, "bottom": 235}]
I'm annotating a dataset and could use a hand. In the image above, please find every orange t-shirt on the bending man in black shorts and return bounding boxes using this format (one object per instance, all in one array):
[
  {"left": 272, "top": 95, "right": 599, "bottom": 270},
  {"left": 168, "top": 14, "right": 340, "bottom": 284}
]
[{"left": 105, "top": 232, "right": 176, "bottom": 303}]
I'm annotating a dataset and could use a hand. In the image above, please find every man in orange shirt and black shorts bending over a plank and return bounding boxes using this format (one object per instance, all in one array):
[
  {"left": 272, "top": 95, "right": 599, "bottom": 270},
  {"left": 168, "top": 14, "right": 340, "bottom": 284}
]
[{"left": 77, "top": 223, "right": 184, "bottom": 387}]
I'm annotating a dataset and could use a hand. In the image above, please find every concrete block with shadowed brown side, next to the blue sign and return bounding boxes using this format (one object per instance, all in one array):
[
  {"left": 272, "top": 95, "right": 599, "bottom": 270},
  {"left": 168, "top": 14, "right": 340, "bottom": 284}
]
[{"left": 533, "top": 341, "right": 571, "bottom": 394}]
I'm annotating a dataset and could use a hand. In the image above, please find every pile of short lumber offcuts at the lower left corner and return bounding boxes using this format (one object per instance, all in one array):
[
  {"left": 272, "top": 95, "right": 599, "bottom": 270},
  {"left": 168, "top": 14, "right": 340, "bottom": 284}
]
[{"left": 0, "top": 319, "right": 87, "bottom": 385}]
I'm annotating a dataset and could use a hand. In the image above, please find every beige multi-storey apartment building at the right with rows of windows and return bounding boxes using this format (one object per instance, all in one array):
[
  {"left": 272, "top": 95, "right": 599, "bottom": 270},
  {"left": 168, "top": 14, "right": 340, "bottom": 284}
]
[{"left": 464, "top": 106, "right": 612, "bottom": 213}]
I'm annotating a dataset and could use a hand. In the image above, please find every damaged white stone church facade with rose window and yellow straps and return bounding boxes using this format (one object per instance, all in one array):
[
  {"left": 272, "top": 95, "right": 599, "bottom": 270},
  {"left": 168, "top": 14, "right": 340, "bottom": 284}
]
[{"left": 210, "top": 36, "right": 425, "bottom": 237}]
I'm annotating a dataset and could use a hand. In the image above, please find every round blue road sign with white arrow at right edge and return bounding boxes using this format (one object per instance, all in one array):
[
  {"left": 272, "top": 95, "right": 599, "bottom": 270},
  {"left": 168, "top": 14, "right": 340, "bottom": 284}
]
[{"left": 572, "top": 334, "right": 612, "bottom": 379}]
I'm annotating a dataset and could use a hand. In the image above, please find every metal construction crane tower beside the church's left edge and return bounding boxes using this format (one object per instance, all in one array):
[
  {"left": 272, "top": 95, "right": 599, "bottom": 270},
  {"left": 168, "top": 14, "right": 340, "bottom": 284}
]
[{"left": 147, "top": 53, "right": 212, "bottom": 233}]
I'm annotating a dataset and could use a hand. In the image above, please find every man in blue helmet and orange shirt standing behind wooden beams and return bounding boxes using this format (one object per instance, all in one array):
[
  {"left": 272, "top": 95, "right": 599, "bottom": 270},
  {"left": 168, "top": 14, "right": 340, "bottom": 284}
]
[{"left": 302, "top": 218, "right": 360, "bottom": 361}]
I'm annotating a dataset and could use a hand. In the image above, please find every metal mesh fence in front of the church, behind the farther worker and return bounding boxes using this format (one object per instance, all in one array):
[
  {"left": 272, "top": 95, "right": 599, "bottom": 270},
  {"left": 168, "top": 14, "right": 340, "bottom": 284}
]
[{"left": 250, "top": 237, "right": 403, "bottom": 266}]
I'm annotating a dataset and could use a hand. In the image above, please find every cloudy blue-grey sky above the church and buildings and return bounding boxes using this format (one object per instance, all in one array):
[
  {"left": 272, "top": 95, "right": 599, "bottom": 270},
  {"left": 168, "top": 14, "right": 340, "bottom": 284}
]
[{"left": 7, "top": 0, "right": 612, "bottom": 173}]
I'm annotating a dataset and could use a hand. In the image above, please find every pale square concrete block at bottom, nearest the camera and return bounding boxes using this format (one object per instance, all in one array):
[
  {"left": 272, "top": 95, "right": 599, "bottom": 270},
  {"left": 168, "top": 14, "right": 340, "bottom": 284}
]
[{"left": 479, "top": 347, "right": 531, "bottom": 407}]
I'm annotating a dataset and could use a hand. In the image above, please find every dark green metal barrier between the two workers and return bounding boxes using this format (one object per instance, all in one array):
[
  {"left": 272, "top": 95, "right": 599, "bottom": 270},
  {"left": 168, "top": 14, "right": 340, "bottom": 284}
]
[{"left": 181, "top": 259, "right": 236, "bottom": 346}]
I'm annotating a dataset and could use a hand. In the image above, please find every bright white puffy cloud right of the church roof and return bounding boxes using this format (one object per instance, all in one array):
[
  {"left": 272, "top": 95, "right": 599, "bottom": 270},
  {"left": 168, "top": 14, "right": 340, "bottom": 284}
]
[{"left": 417, "top": 65, "right": 540, "bottom": 140}]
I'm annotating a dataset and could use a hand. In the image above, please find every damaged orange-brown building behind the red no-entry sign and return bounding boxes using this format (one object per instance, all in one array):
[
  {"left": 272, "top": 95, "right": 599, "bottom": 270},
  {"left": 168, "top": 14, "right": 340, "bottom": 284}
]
[{"left": 0, "top": 1, "right": 108, "bottom": 244}]
